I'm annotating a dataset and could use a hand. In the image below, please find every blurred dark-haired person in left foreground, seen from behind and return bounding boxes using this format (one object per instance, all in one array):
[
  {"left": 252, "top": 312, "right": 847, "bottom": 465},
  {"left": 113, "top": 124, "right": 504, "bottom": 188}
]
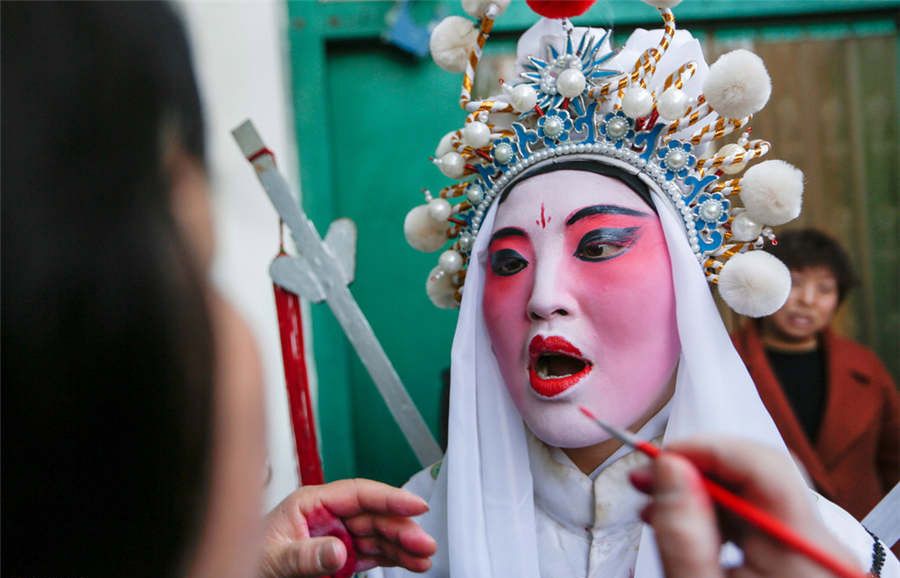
[{"left": 2, "top": 2, "right": 263, "bottom": 576}]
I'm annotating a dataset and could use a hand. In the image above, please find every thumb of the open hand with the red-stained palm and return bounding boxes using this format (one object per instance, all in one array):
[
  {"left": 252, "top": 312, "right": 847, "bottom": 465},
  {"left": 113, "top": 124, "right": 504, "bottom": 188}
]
[{"left": 264, "top": 536, "right": 347, "bottom": 578}]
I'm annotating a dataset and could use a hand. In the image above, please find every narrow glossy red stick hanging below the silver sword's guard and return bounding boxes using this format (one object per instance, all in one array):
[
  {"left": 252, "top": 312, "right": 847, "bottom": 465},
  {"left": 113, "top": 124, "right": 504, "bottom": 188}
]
[{"left": 272, "top": 283, "right": 325, "bottom": 486}]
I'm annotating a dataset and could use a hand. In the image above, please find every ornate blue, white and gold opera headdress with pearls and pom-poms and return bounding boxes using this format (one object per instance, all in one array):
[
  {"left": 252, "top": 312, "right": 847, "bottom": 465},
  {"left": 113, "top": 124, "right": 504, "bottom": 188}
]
[{"left": 404, "top": 0, "right": 803, "bottom": 317}]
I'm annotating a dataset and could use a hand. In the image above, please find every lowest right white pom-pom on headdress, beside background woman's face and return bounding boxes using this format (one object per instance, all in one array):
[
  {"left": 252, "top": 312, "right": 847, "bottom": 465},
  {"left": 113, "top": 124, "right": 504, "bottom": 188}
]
[{"left": 719, "top": 251, "right": 791, "bottom": 317}]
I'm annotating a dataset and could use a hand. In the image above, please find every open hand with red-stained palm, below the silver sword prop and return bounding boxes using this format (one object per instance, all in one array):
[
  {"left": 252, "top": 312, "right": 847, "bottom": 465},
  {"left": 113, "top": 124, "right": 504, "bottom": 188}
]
[{"left": 260, "top": 479, "right": 437, "bottom": 578}]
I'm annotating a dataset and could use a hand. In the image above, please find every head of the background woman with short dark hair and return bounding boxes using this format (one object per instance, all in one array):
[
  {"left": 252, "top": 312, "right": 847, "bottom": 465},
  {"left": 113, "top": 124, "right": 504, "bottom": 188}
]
[{"left": 763, "top": 229, "right": 856, "bottom": 349}]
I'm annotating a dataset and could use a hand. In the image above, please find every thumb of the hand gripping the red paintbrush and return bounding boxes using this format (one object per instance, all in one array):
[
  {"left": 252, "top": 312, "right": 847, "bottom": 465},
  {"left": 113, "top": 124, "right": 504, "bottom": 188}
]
[{"left": 647, "top": 453, "right": 723, "bottom": 578}]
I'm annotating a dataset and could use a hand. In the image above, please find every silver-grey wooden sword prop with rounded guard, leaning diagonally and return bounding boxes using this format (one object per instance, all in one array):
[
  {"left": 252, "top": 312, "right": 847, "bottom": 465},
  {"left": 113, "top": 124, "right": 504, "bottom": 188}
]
[{"left": 232, "top": 120, "right": 441, "bottom": 466}]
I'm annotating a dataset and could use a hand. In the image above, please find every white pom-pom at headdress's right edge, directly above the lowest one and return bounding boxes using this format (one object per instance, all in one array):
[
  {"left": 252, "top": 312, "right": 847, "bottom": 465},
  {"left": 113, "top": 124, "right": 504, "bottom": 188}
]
[{"left": 741, "top": 160, "right": 803, "bottom": 225}]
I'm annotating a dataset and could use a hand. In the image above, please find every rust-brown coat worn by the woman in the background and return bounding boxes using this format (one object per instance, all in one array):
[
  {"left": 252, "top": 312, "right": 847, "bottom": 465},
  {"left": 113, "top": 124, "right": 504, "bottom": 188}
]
[{"left": 732, "top": 321, "right": 900, "bottom": 519}]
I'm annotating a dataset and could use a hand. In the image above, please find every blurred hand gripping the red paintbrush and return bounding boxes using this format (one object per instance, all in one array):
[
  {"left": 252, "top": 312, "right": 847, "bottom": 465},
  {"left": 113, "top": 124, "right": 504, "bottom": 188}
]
[{"left": 631, "top": 439, "right": 856, "bottom": 578}]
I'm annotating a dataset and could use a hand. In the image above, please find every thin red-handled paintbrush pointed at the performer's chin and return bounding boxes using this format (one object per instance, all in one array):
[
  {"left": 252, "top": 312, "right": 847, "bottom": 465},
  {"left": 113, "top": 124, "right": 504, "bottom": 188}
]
[{"left": 578, "top": 406, "right": 868, "bottom": 578}]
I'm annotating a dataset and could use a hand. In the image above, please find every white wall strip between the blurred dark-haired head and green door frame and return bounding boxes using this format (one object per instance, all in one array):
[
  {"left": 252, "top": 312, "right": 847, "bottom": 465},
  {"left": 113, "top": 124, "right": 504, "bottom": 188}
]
[{"left": 180, "top": 0, "right": 315, "bottom": 507}]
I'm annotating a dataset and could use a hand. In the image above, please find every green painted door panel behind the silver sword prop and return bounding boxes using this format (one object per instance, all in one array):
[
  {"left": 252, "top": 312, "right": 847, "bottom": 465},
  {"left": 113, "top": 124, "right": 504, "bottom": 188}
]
[{"left": 326, "top": 44, "right": 461, "bottom": 483}]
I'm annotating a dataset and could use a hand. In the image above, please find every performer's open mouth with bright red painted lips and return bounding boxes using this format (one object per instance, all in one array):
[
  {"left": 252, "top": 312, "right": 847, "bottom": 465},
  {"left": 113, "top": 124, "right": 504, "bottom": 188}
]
[{"left": 528, "top": 335, "right": 591, "bottom": 397}]
